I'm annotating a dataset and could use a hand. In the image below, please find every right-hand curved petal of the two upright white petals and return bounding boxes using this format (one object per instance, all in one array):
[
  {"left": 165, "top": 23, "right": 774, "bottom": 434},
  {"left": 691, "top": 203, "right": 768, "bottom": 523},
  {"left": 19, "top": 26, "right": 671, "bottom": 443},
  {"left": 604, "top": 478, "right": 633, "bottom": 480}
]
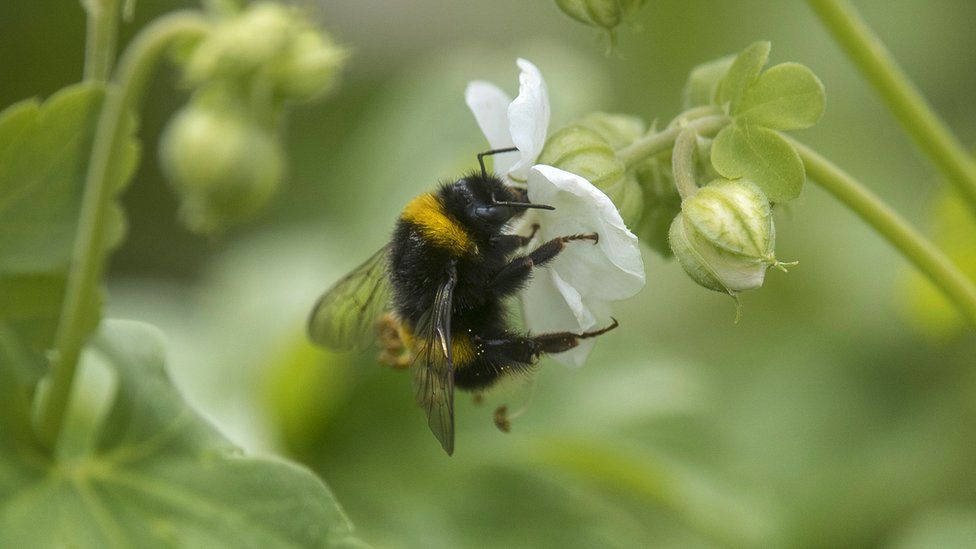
[{"left": 508, "top": 59, "right": 549, "bottom": 181}]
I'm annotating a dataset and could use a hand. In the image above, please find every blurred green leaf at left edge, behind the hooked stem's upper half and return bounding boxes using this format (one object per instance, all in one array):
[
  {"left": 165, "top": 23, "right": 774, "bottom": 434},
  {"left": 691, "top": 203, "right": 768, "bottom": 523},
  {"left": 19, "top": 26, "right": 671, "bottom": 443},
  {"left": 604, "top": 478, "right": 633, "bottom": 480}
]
[{"left": 0, "top": 84, "right": 139, "bottom": 384}]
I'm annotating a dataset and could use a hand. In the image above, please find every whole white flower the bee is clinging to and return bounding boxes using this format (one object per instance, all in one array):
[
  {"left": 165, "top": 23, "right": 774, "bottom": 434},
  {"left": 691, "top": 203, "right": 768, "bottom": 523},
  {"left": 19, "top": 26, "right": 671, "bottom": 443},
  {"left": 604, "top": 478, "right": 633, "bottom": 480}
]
[{"left": 465, "top": 59, "right": 644, "bottom": 366}]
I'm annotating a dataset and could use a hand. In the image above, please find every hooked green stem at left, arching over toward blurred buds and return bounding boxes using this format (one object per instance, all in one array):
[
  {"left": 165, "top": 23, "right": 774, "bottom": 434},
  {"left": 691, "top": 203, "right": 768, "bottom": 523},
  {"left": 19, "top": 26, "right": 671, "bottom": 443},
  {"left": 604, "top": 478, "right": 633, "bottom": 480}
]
[{"left": 38, "top": 11, "right": 207, "bottom": 448}]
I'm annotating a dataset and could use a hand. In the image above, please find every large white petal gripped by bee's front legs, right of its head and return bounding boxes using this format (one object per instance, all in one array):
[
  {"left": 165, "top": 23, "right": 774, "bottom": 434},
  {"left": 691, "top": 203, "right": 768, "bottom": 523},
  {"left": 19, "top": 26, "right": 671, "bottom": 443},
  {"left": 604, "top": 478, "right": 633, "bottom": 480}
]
[{"left": 528, "top": 164, "right": 644, "bottom": 302}]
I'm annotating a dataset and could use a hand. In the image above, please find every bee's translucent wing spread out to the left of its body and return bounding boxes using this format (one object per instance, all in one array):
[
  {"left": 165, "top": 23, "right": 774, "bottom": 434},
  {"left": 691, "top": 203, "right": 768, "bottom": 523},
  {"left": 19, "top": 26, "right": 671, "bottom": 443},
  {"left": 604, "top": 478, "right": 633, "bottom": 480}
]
[{"left": 308, "top": 245, "right": 390, "bottom": 351}]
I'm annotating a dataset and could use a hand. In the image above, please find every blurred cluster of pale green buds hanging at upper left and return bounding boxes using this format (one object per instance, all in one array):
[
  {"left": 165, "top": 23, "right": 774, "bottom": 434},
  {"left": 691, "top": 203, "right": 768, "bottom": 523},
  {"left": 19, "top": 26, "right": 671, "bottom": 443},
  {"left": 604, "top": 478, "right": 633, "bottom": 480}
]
[{"left": 160, "top": 3, "right": 345, "bottom": 232}]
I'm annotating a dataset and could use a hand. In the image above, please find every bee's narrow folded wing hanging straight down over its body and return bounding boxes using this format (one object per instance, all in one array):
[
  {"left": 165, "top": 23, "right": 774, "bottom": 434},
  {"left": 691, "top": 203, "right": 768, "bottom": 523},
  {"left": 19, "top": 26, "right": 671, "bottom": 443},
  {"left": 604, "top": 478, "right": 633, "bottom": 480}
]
[{"left": 411, "top": 263, "right": 457, "bottom": 455}]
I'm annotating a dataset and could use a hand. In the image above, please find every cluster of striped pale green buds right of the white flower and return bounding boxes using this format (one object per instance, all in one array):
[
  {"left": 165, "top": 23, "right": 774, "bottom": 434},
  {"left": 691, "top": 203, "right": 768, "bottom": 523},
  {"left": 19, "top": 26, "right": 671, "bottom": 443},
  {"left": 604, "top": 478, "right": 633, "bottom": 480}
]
[{"left": 539, "top": 108, "right": 785, "bottom": 295}]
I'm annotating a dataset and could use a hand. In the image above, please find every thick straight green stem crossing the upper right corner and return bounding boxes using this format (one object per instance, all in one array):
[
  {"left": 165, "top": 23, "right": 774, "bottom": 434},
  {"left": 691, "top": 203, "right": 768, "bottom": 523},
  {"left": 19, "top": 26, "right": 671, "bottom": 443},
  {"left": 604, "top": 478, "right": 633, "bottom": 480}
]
[{"left": 809, "top": 0, "right": 976, "bottom": 210}]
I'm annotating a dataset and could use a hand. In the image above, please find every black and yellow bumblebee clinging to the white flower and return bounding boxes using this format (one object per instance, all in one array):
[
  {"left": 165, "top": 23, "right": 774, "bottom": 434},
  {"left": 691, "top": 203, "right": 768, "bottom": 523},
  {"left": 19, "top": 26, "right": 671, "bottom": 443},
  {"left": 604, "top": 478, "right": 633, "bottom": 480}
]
[{"left": 308, "top": 148, "right": 617, "bottom": 455}]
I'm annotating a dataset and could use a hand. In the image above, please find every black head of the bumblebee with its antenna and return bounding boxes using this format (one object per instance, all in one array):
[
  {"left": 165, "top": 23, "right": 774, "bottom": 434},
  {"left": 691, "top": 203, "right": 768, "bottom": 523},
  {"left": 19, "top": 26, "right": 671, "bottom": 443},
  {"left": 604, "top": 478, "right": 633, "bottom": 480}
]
[{"left": 441, "top": 173, "right": 554, "bottom": 236}]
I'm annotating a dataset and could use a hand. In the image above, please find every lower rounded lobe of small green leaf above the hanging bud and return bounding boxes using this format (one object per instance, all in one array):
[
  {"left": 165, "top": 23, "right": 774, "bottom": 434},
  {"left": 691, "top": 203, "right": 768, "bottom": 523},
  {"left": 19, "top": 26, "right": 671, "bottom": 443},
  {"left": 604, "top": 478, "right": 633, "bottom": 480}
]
[{"left": 712, "top": 124, "right": 806, "bottom": 202}]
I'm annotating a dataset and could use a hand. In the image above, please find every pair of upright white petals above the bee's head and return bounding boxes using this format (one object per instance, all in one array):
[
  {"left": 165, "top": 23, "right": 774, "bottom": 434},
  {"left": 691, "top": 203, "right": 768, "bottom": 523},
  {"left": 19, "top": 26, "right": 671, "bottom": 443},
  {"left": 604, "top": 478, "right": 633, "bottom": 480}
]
[{"left": 464, "top": 59, "right": 549, "bottom": 184}]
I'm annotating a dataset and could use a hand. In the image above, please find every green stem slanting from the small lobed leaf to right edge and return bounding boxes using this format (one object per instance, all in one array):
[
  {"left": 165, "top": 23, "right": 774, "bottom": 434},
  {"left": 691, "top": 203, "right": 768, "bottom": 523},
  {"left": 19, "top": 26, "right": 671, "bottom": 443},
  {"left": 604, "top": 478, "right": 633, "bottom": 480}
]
[{"left": 787, "top": 138, "right": 976, "bottom": 326}]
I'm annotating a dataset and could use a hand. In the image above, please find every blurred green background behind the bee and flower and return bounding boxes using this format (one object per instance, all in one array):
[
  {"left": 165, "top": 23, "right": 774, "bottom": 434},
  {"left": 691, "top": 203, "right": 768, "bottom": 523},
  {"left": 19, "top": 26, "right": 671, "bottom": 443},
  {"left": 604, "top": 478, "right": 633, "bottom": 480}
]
[{"left": 0, "top": 0, "right": 976, "bottom": 547}]
